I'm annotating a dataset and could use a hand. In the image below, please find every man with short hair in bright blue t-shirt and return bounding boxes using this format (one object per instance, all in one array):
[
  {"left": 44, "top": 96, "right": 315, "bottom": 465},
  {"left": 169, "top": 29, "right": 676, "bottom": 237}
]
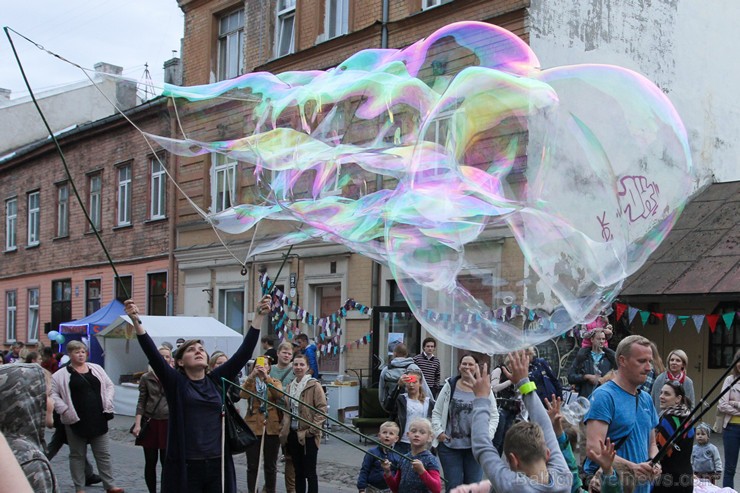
[{"left": 583, "top": 335, "right": 660, "bottom": 493}]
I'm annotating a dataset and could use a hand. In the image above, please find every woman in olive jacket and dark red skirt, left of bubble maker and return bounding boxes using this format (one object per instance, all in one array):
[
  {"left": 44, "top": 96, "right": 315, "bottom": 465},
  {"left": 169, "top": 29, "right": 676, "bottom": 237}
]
[{"left": 131, "top": 346, "right": 172, "bottom": 493}]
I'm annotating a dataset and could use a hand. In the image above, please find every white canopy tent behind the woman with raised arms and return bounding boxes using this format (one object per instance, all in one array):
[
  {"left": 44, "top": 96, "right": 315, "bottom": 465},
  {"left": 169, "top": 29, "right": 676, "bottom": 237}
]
[{"left": 95, "top": 315, "right": 244, "bottom": 416}]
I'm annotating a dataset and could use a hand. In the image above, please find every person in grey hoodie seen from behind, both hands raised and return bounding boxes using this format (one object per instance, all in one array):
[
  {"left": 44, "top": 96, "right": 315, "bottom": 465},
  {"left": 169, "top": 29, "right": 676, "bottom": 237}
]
[{"left": 472, "top": 351, "right": 573, "bottom": 493}]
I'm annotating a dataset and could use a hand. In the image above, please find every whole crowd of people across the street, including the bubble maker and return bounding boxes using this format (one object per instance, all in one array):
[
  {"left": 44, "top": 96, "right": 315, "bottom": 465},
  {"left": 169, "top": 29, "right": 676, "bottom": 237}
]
[{"left": 0, "top": 308, "right": 740, "bottom": 493}]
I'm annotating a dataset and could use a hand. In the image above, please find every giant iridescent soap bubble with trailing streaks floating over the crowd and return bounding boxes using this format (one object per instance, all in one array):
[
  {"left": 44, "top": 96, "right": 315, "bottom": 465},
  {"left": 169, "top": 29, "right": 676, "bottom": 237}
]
[{"left": 151, "top": 22, "right": 699, "bottom": 353}]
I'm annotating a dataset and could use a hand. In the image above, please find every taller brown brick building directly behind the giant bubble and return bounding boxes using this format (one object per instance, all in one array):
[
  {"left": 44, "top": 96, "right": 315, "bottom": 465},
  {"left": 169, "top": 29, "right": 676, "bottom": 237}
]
[{"left": 172, "top": 0, "right": 529, "bottom": 376}]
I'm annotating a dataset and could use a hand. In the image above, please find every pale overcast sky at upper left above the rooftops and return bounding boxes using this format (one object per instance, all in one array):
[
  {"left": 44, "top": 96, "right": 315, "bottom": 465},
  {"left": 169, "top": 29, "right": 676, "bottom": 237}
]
[{"left": 0, "top": 0, "right": 183, "bottom": 99}]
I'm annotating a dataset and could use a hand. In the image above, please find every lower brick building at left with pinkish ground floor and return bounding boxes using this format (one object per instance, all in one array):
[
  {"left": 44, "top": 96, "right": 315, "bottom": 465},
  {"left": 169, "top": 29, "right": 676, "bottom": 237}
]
[{"left": 0, "top": 98, "right": 174, "bottom": 348}]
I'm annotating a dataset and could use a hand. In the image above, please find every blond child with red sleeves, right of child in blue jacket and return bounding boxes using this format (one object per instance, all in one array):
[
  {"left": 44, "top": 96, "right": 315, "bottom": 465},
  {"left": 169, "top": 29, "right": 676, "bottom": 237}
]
[{"left": 383, "top": 418, "right": 440, "bottom": 493}]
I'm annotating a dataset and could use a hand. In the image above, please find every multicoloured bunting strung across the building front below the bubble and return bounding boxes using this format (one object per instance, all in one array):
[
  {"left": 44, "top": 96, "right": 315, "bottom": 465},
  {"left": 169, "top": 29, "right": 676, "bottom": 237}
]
[{"left": 260, "top": 275, "right": 372, "bottom": 355}]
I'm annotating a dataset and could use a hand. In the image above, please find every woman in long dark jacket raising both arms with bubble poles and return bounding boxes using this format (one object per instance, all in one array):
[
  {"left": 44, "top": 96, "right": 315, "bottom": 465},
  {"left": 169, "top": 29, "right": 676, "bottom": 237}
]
[{"left": 125, "top": 296, "right": 270, "bottom": 493}]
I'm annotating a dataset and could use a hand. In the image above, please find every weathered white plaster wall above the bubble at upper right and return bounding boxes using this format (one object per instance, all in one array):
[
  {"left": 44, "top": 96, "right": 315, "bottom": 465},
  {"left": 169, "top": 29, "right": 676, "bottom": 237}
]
[{"left": 530, "top": 0, "right": 740, "bottom": 182}]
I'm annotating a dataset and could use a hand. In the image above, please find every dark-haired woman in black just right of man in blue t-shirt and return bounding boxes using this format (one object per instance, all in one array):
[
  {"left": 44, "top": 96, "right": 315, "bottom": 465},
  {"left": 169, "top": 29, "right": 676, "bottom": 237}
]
[{"left": 653, "top": 380, "right": 694, "bottom": 493}]
